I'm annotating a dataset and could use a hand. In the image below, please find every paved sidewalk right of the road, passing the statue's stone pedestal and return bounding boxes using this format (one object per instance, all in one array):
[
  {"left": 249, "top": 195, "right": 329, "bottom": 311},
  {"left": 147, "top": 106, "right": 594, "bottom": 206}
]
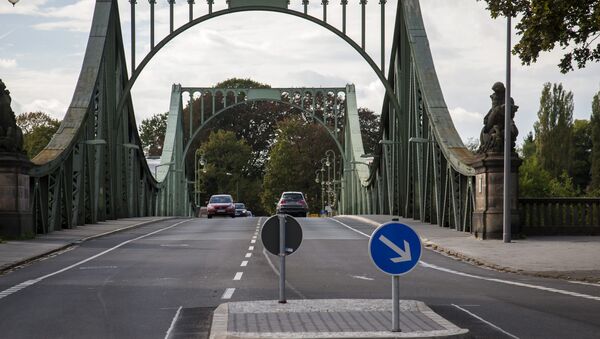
[{"left": 338, "top": 215, "right": 600, "bottom": 283}]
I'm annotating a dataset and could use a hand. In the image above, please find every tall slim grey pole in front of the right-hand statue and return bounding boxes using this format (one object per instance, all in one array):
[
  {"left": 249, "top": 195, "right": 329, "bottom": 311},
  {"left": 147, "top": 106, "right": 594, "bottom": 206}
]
[{"left": 502, "top": 14, "right": 512, "bottom": 243}]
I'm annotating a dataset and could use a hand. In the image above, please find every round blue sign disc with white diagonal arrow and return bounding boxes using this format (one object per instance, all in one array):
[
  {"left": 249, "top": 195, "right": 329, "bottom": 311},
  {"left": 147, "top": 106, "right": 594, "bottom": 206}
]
[{"left": 369, "top": 221, "right": 422, "bottom": 275}]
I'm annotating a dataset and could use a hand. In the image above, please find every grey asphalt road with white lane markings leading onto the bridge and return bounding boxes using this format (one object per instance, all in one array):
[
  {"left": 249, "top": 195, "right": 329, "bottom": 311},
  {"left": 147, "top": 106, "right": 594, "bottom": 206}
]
[{"left": 0, "top": 218, "right": 600, "bottom": 338}]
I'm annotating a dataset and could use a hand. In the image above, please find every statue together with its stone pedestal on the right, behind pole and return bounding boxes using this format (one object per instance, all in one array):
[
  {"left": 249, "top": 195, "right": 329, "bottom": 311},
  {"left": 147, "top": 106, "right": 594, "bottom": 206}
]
[{"left": 472, "top": 82, "right": 521, "bottom": 239}]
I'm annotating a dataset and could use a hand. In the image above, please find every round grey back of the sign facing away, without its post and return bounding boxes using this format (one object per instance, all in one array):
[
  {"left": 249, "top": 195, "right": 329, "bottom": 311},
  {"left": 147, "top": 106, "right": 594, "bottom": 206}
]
[{"left": 260, "top": 215, "right": 302, "bottom": 255}]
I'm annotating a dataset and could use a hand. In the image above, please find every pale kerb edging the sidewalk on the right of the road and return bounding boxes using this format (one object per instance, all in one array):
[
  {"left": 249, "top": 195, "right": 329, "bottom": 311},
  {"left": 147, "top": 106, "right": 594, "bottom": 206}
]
[{"left": 336, "top": 215, "right": 597, "bottom": 283}]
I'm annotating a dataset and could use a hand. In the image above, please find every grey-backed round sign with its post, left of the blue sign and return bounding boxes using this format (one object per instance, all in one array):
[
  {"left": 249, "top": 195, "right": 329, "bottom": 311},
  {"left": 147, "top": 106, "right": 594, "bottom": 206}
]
[{"left": 260, "top": 214, "right": 302, "bottom": 304}]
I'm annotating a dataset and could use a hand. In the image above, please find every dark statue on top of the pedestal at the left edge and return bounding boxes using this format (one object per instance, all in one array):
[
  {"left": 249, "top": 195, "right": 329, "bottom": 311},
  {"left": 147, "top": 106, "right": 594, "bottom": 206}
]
[{"left": 0, "top": 79, "right": 24, "bottom": 153}]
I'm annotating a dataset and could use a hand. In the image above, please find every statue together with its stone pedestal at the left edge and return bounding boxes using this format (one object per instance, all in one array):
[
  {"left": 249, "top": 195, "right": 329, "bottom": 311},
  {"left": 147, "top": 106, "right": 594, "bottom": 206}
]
[{"left": 0, "top": 79, "right": 34, "bottom": 238}]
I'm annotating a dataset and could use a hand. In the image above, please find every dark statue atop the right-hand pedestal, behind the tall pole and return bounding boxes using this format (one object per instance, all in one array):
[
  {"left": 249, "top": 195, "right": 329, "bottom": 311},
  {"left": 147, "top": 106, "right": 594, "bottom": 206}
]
[{"left": 477, "top": 82, "right": 519, "bottom": 154}]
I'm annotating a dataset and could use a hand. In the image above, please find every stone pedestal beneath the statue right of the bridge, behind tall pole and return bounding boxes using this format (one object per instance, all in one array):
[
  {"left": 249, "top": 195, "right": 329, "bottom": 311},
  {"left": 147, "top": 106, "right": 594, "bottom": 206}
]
[{"left": 472, "top": 152, "right": 521, "bottom": 239}]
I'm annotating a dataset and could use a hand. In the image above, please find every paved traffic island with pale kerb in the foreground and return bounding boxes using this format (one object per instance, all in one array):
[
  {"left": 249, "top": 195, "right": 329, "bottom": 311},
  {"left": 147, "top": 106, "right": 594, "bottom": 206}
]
[{"left": 209, "top": 299, "right": 469, "bottom": 339}]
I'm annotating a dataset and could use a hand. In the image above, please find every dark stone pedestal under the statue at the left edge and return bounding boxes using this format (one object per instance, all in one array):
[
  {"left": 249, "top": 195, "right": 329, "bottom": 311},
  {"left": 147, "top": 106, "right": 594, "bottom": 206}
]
[{"left": 0, "top": 152, "right": 35, "bottom": 239}]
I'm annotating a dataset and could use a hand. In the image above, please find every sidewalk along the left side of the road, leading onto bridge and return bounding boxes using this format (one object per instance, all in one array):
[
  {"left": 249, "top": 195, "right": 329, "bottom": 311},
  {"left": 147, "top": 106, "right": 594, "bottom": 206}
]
[{"left": 0, "top": 217, "right": 173, "bottom": 274}]
